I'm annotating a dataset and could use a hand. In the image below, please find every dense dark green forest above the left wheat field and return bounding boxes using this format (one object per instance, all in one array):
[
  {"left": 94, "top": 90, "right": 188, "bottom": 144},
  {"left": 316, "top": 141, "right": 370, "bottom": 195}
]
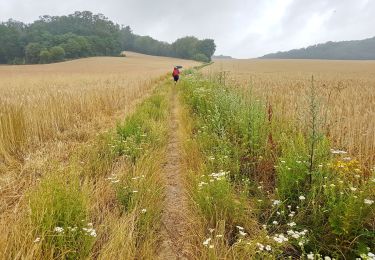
[{"left": 0, "top": 11, "right": 216, "bottom": 64}]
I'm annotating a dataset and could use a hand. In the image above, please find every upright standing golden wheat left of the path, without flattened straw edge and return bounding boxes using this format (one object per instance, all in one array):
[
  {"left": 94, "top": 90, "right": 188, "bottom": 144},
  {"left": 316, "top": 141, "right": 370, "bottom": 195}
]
[{"left": 0, "top": 53, "right": 200, "bottom": 165}]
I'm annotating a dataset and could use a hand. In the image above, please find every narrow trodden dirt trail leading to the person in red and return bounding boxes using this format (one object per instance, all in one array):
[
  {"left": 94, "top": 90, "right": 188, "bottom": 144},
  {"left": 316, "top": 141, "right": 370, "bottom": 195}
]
[{"left": 158, "top": 86, "right": 189, "bottom": 260}]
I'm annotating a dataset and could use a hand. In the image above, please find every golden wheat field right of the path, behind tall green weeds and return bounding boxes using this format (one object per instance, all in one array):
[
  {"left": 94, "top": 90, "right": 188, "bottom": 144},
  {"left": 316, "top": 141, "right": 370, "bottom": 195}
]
[{"left": 205, "top": 59, "right": 375, "bottom": 167}]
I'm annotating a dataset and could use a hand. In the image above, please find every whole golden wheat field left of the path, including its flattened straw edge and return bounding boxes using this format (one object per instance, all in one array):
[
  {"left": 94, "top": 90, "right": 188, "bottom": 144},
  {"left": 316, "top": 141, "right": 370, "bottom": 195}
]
[{"left": 0, "top": 52, "right": 198, "bottom": 233}]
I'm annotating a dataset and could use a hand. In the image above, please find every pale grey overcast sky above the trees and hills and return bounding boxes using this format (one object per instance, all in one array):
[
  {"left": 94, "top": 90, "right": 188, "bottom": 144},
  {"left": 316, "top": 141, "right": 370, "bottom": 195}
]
[{"left": 0, "top": 0, "right": 375, "bottom": 58}]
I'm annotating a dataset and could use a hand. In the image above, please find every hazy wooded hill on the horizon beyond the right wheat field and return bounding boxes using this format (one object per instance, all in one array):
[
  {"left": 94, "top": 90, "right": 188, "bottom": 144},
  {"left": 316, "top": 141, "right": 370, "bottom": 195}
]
[{"left": 260, "top": 37, "right": 375, "bottom": 60}]
